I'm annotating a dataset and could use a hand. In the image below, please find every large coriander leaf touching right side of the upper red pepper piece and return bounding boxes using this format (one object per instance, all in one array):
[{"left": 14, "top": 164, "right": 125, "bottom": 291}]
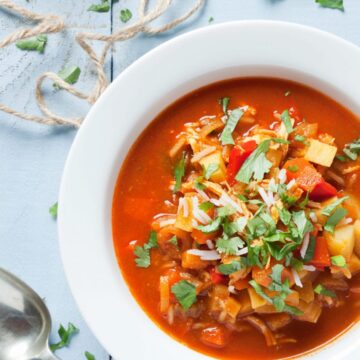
[{"left": 235, "top": 140, "right": 272, "bottom": 184}]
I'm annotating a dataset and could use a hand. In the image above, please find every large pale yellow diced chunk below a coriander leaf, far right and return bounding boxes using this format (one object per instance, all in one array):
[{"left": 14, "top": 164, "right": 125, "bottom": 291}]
[{"left": 324, "top": 225, "right": 355, "bottom": 260}]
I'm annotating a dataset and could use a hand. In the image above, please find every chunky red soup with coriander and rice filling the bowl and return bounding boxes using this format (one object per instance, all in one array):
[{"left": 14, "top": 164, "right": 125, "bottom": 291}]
[{"left": 113, "top": 78, "right": 360, "bottom": 359}]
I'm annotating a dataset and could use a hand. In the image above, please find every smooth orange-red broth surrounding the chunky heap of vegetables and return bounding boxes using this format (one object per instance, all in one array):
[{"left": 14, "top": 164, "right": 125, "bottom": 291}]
[{"left": 112, "top": 78, "right": 360, "bottom": 359}]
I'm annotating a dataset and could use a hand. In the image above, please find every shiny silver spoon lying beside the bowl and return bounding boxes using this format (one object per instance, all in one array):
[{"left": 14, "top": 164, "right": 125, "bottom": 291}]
[{"left": 0, "top": 268, "right": 59, "bottom": 360}]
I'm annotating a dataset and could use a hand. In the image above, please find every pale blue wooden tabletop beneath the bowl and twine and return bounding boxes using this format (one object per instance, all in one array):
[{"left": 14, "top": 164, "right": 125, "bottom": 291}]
[{"left": 0, "top": 0, "right": 360, "bottom": 360}]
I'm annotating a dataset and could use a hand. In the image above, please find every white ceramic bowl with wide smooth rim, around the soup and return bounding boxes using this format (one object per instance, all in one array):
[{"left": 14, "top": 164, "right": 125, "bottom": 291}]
[{"left": 58, "top": 21, "right": 360, "bottom": 360}]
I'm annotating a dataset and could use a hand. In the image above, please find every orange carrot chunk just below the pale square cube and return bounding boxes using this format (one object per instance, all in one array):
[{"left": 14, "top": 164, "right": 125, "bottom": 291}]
[{"left": 284, "top": 158, "right": 324, "bottom": 191}]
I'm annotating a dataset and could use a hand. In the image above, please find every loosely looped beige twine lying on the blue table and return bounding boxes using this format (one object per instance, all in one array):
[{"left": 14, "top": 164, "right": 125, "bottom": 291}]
[{"left": 0, "top": 0, "right": 206, "bottom": 127}]
